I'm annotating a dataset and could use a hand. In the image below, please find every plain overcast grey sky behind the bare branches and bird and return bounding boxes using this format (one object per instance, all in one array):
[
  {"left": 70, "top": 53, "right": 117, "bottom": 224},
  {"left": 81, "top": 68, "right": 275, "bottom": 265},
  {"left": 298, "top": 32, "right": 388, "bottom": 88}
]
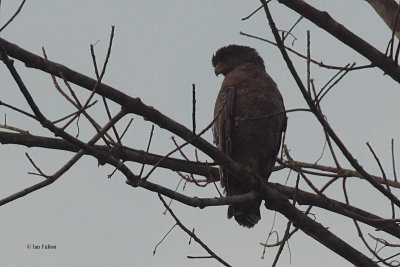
[{"left": 0, "top": 0, "right": 400, "bottom": 267}]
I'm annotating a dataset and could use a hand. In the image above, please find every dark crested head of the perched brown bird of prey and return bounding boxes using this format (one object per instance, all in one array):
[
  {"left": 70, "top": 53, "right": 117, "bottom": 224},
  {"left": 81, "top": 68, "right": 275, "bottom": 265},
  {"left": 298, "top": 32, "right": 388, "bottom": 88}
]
[{"left": 212, "top": 45, "right": 264, "bottom": 76}]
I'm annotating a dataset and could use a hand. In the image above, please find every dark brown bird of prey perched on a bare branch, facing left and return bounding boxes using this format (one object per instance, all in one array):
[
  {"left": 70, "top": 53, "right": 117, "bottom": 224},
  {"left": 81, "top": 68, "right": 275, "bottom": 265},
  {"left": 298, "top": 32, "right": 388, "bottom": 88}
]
[{"left": 212, "top": 45, "right": 286, "bottom": 228}]
